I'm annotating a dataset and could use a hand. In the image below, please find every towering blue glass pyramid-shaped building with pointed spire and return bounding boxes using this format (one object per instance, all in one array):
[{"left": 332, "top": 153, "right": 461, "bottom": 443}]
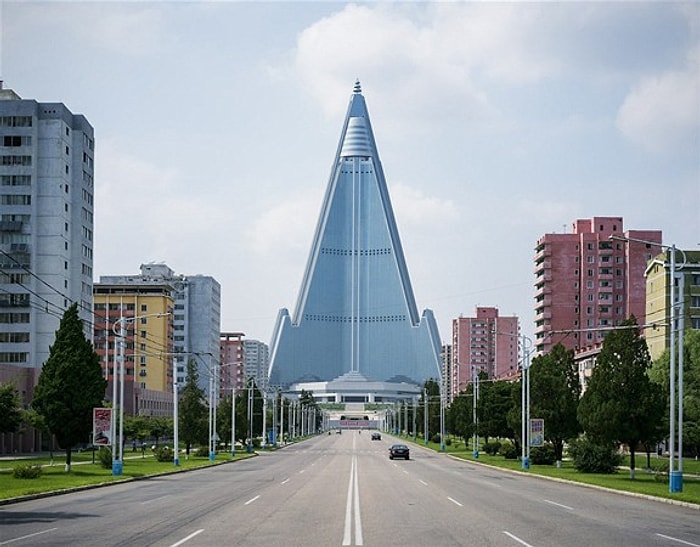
[{"left": 269, "top": 82, "right": 440, "bottom": 396}]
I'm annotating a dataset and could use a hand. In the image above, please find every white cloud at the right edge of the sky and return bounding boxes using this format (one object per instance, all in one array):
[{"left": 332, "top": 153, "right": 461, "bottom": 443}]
[{"left": 617, "top": 48, "right": 700, "bottom": 153}]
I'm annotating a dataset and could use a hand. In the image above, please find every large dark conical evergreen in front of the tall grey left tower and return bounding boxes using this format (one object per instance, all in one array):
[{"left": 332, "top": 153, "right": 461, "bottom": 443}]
[{"left": 32, "top": 304, "right": 107, "bottom": 472}]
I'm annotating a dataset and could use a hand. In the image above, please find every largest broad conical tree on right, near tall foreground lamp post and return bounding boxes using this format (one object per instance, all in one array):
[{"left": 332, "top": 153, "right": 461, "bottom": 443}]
[{"left": 578, "top": 317, "right": 663, "bottom": 478}]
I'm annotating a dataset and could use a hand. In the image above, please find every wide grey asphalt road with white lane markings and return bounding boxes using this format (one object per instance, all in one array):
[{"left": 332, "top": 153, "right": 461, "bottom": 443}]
[{"left": 0, "top": 431, "right": 700, "bottom": 547}]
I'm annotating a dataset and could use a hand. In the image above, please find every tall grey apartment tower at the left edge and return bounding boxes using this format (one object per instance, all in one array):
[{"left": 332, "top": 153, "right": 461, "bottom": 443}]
[{"left": 0, "top": 81, "right": 95, "bottom": 452}]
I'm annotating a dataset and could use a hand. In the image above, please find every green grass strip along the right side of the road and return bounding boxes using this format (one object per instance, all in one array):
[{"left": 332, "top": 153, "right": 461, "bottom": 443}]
[{"left": 400, "top": 437, "right": 700, "bottom": 509}]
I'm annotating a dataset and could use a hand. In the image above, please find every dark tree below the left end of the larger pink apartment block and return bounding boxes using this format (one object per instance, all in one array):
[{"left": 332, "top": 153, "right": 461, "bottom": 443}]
[{"left": 530, "top": 344, "right": 581, "bottom": 462}]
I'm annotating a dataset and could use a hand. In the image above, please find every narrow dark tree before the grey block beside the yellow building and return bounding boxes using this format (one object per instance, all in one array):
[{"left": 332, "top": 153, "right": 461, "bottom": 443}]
[{"left": 175, "top": 359, "right": 209, "bottom": 458}]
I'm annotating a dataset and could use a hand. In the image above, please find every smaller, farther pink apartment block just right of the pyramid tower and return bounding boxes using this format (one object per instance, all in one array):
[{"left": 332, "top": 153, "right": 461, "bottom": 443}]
[{"left": 450, "top": 307, "right": 520, "bottom": 397}]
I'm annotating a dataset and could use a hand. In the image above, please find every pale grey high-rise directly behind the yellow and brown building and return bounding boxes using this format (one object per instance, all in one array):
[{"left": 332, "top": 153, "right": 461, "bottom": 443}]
[{"left": 100, "top": 263, "right": 221, "bottom": 392}]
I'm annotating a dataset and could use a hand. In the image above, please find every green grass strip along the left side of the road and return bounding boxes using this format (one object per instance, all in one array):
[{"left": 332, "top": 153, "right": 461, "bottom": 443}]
[{"left": 0, "top": 452, "right": 255, "bottom": 501}]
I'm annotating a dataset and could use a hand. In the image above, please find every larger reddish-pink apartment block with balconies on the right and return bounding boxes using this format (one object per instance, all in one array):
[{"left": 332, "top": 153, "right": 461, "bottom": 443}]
[{"left": 534, "top": 217, "right": 662, "bottom": 354}]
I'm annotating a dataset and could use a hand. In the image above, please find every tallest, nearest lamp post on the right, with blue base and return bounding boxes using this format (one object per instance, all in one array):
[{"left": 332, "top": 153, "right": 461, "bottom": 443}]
[{"left": 610, "top": 235, "right": 687, "bottom": 493}]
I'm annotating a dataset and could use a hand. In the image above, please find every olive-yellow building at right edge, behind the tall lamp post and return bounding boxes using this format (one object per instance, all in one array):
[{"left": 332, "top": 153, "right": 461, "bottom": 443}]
[{"left": 644, "top": 250, "right": 700, "bottom": 359}]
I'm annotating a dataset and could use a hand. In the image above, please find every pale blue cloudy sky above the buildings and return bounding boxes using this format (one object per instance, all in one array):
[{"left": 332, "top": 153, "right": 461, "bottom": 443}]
[{"left": 0, "top": 1, "right": 700, "bottom": 342}]
